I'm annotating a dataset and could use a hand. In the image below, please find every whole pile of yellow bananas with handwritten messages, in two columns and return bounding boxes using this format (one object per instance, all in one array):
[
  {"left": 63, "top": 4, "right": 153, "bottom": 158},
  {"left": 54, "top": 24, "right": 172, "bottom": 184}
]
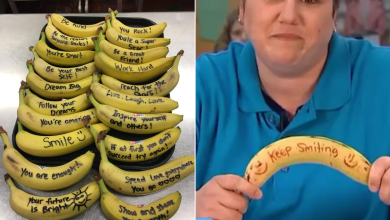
[{"left": 0, "top": 9, "right": 195, "bottom": 220}]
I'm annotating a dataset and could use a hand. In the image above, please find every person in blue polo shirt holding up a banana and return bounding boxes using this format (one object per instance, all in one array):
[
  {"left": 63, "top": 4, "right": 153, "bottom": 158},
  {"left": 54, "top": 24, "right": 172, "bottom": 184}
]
[{"left": 196, "top": 0, "right": 390, "bottom": 220}]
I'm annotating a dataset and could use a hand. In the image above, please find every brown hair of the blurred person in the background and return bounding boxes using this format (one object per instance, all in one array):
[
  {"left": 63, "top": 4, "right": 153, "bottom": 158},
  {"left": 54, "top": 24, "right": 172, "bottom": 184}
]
[{"left": 214, "top": 9, "right": 238, "bottom": 52}]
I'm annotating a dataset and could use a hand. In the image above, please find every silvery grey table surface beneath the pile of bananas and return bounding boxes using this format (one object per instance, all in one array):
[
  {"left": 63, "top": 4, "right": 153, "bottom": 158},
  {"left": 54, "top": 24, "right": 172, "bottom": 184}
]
[{"left": 0, "top": 12, "right": 195, "bottom": 220}]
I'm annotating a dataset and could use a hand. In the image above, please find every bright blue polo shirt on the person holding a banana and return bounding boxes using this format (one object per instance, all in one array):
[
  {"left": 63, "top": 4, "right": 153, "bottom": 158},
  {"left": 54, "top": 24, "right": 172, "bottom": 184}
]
[{"left": 196, "top": 34, "right": 390, "bottom": 220}]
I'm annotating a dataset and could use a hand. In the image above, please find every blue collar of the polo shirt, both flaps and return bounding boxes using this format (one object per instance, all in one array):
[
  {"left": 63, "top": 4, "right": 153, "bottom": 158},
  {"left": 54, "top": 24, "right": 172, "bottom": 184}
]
[{"left": 237, "top": 33, "right": 351, "bottom": 112}]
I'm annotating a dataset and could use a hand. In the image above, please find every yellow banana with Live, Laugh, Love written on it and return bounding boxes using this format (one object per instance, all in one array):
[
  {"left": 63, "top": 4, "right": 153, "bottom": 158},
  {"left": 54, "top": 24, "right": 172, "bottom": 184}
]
[{"left": 91, "top": 71, "right": 179, "bottom": 113}]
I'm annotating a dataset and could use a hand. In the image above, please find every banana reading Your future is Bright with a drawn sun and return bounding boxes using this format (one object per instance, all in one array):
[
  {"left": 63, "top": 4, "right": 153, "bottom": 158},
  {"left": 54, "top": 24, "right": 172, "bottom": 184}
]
[{"left": 4, "top": 174, "right": 100, "bottom": 220}]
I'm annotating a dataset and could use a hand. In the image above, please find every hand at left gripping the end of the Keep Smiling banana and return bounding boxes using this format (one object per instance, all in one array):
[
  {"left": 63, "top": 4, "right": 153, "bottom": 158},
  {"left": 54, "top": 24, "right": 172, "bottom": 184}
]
[{"left": 196, "top": 175, "right": 263, "bottom": 220}]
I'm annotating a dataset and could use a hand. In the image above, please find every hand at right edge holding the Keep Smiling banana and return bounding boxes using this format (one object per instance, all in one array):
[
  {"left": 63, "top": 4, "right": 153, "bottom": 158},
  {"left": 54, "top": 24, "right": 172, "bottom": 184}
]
[{"left": 368, "top": 156, "right": 390, "bottom": 205}]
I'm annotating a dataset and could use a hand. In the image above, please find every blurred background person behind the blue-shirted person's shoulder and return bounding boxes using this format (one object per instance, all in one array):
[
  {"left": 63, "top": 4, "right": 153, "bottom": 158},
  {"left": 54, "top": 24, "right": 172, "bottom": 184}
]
[{"left": 214, "top": 9, "right": 246, "bottom": 52}]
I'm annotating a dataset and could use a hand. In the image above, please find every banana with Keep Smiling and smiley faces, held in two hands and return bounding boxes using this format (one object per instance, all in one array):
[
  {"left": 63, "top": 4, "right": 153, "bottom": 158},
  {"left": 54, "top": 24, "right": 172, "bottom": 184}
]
[{"left": 245, "top": 136, "right": 371, "bottom": 186}]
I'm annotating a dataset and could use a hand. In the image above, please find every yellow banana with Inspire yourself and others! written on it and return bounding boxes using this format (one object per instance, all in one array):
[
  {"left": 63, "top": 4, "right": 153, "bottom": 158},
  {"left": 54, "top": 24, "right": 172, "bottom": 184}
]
[{"left": 87, "top": 90, "right": 183, "bottom": 134}]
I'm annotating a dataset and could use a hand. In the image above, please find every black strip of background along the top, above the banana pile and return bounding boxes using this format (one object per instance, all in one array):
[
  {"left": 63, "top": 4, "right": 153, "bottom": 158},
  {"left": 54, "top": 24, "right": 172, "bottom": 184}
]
[{"left": 0, "top": 0, "right": 195, "bottom": 14}]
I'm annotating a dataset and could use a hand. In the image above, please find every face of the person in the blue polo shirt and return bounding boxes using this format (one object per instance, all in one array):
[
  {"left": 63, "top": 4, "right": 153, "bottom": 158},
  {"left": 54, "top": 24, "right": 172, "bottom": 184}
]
[{"left": 240, "top": 0, "right": 334, "bottom": 65}]
